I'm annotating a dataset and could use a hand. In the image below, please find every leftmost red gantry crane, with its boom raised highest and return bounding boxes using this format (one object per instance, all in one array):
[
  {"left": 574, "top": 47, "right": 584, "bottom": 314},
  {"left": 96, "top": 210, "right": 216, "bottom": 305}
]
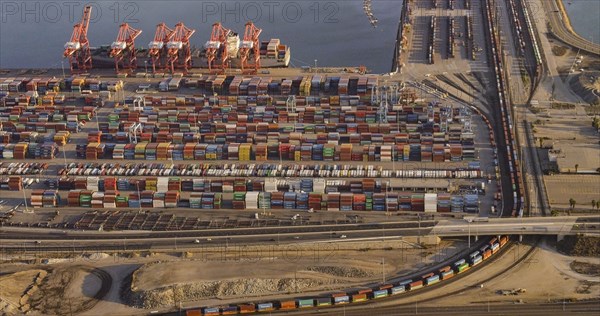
[{"left": 63, "top": 6, "right": 92, "bottom": 72}]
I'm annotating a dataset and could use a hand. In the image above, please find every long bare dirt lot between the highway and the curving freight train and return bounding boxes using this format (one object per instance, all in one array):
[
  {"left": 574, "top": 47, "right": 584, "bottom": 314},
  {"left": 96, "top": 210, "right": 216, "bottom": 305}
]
[{"left": 130, "top": 241, "right": 458, "bottom": 308}]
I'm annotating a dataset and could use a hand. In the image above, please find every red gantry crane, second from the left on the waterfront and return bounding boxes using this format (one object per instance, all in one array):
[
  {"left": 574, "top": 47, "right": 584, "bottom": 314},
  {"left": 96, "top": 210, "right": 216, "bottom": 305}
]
[{"left": 109, "top": 23, "right": 142, "bottom": 73}]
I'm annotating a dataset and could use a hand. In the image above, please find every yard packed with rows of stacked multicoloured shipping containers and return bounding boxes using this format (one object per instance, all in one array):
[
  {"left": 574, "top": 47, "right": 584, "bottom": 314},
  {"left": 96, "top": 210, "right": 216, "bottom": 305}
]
[{"left": 0, "top": 69, "right": 499, "bottom": 229}]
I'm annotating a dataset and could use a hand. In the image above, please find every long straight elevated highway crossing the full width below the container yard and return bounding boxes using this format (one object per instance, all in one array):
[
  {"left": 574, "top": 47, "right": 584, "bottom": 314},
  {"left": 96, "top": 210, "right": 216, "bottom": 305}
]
[{"left": 0, "top": 216, "right": 600, "bottom": 252}]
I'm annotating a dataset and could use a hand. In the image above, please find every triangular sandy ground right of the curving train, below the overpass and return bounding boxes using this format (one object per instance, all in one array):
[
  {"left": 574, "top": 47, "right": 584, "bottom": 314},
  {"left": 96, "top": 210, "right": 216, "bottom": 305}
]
[{"left": 370, "top": 238, "right": 600, "bottom": 311}]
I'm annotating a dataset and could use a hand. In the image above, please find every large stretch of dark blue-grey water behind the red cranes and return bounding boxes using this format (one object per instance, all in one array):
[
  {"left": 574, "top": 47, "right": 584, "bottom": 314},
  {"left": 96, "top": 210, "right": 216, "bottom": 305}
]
[{"left": 0, "top": 0, "right": 402, "bottom": 72}]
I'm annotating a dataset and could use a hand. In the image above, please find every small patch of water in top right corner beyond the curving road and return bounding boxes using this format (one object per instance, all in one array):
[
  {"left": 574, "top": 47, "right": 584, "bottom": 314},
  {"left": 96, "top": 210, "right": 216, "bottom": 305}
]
[{"left": 563, "top": 0, "right": 600, "bottom": 43}]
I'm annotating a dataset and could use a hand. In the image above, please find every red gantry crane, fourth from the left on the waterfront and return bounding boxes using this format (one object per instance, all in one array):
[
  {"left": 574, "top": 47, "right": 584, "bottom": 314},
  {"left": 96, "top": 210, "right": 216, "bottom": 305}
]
[{"left": 167, "top": 22, "right": 196, "bottom": 73}]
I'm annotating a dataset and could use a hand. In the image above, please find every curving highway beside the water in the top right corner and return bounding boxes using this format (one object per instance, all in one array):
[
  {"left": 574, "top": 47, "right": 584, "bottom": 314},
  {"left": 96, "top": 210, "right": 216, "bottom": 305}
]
[{"left": 541, "top": 0, "right": 600, "bottom": 55}]
